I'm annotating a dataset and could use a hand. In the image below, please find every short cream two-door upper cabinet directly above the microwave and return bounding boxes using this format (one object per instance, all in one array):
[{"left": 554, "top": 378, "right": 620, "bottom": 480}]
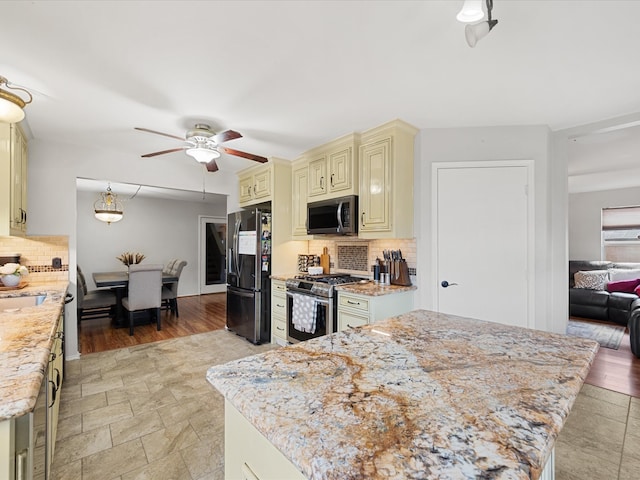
[{"left": 305, "top": 133, "right": 359, "bottom": 202}]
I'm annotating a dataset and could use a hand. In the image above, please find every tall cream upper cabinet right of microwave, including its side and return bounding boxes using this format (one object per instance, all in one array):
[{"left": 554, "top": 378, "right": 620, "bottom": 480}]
[{"left": 358, "top": 120, "right": 418, "bottom": 239}]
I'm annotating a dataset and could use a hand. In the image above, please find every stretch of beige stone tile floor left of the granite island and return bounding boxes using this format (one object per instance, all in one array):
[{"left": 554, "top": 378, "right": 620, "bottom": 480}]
[{"left": 51, "top": 330, "right": 277, "bottom": 480}]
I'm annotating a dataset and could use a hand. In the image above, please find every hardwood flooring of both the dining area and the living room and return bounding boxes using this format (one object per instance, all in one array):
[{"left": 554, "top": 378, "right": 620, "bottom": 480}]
[{"left": 79, "top": 293, "right": 640, "bottom": 397}]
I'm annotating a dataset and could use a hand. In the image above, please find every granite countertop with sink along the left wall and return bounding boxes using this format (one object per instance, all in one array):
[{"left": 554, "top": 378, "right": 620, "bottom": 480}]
[{"left": 0, "top": 281, "right": 68, "bottom": 421}]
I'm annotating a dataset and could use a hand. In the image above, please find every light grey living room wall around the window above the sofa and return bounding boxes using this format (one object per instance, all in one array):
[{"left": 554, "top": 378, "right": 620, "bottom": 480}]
[{"left": 569, "top": 187, "right": 640, "bottom": 260}]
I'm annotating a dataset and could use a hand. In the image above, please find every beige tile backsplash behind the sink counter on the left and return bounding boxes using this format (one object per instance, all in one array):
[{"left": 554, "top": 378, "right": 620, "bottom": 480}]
[{"left": 0, "top": 236, "right": 69, "bottom": 282}]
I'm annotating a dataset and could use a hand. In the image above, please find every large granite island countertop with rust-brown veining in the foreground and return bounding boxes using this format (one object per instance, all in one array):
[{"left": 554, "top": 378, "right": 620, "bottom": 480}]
[{"left": 207, "top": 310, "right": 598, "bottom": 479}]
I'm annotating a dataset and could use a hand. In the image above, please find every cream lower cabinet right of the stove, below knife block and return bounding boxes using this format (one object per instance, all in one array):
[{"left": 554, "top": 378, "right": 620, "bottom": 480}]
[{"left": 338, "top": 290, "right": 413, "bottom": 331}]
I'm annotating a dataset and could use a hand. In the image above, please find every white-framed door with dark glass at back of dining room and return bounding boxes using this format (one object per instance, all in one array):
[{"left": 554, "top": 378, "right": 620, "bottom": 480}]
[{"left": 198, "top": 217, "right": 227, "bottom": 294}]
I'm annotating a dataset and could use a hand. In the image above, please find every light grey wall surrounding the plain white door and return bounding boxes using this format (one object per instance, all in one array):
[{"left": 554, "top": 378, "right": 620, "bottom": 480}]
[{"left": 414, "top": 126, "right": 568, "bottom": 333}]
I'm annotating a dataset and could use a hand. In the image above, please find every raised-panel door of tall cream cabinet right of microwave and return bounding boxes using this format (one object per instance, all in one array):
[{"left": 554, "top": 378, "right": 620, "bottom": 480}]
[{"left": 360, "top": 138, "right": 392, "bottom": 232}]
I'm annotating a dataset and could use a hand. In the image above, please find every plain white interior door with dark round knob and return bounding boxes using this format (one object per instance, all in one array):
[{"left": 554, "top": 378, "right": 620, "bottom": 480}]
[{"left": 433, "top": 161, "right": 534, "bottom": 327}]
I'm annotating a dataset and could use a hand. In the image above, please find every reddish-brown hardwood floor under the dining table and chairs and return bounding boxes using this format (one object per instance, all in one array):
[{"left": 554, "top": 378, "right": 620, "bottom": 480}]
[{"left": 78, "top": 293, "right": 226, "bottom": 354}]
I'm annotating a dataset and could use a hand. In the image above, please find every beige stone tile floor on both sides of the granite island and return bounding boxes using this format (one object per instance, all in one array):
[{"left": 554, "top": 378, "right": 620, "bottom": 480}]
[{"left": 52, "top": 330, "right": 640, "bottom": 480}]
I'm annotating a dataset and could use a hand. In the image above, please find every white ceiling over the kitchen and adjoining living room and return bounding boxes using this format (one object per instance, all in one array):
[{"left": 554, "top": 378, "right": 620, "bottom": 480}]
[{"left": 0, "top": 0, "right": 640, "bottom": 195}]
